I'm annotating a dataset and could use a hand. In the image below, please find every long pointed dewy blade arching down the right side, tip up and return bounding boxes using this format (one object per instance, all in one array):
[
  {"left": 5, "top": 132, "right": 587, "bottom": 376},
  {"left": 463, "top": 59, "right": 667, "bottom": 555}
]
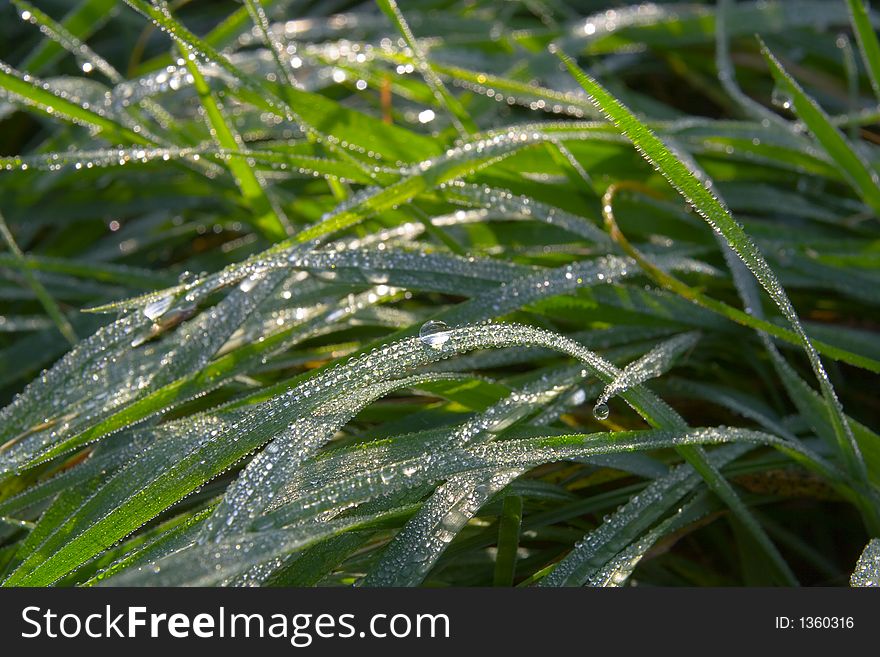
[{"left": 558, "top": 47, "right": 867, "bottom": 481}]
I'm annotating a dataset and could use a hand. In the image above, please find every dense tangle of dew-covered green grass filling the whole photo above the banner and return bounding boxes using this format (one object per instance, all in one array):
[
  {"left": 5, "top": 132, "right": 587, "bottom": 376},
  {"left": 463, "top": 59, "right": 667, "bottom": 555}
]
[{"left": 0, "top": 0, "right": 880, "bottom": 586}]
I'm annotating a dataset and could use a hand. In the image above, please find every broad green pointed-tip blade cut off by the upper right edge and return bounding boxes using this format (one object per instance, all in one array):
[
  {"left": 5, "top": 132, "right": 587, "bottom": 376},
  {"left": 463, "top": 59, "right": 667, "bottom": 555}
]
[{"left": 760, "top": 41, "right": 880, "bottom": 215}]
